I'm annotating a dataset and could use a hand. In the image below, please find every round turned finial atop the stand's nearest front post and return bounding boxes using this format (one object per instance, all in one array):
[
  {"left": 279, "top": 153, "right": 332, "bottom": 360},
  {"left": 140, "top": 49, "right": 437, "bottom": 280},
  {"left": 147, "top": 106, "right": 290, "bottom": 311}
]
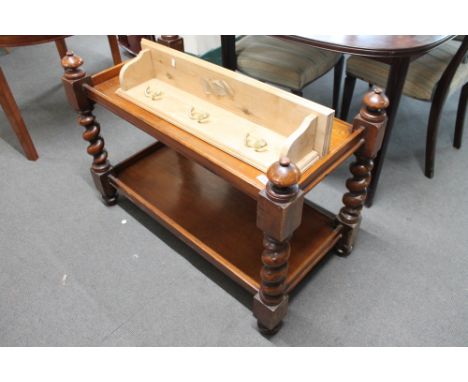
[{"left": 267, "top": 157, "right": 301, "bottom": 201}]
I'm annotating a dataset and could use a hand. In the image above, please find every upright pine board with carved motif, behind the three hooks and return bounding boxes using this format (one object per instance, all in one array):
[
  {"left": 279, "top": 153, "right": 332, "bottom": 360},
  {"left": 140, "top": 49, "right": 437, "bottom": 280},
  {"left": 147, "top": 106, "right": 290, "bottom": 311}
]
[{"left": 142, "top": 40, "right": 333, "bottom": 142}]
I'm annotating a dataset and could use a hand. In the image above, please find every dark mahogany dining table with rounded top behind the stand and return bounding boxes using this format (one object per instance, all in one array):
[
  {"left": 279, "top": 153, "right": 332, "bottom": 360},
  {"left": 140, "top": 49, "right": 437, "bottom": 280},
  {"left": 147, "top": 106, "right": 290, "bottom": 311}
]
[{"left": 221, "top": 35, "right": 455, "bottom": 207}]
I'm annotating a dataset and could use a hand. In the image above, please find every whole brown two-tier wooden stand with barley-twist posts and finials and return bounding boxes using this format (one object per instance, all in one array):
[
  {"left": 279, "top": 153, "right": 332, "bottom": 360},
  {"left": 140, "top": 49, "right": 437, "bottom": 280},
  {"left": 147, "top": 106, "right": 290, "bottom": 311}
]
[{"left": 62, "top": 42, "right": 388, "bottom": 333}]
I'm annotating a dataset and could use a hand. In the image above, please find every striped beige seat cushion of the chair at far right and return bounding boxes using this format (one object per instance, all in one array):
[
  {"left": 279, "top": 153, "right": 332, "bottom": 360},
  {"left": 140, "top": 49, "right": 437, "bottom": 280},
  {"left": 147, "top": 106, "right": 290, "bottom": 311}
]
[{"left": 346, "top": 40, "right": 468, "bottom": 101}]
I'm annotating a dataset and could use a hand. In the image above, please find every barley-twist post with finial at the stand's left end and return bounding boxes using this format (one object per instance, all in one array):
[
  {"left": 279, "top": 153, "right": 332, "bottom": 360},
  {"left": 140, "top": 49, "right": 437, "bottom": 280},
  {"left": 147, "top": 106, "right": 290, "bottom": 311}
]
[{"left": 62, "top": 52, "right": 117, "bottom": 205}]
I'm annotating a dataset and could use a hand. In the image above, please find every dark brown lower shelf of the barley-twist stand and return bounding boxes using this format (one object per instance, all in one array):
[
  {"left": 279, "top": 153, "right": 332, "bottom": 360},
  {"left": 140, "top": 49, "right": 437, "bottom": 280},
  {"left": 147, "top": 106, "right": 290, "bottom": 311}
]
[{"left": 110, "top": 143, "right": 341, "bottom": 293}]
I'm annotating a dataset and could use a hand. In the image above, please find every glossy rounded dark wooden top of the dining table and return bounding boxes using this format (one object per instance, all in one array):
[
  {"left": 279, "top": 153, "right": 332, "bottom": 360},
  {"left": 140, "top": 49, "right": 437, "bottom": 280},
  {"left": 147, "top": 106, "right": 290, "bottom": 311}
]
[{"left": 278, "top": 35, "right": 455, "bottom": 57}]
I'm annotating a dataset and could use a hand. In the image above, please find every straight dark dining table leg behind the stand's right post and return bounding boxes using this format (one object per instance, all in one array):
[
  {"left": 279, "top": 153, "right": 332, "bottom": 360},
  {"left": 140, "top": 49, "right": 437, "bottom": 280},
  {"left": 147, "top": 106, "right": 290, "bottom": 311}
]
[{"left": 366, "top": 57, "right": 410, "bottom": 207}]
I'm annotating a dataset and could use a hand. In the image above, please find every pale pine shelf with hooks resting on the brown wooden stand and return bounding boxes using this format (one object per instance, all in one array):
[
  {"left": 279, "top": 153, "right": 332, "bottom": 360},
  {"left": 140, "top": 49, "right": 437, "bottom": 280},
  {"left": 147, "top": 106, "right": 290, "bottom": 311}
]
[{"left": 117, "top": 41, "right": 333, "bottom": 172}]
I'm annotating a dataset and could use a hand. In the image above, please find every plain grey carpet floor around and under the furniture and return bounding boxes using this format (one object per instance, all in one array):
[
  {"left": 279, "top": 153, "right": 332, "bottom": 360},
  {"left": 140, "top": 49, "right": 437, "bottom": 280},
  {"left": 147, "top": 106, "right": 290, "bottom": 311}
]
[{"left": 0, "top": 36, "right": 468, "bottom": 346}]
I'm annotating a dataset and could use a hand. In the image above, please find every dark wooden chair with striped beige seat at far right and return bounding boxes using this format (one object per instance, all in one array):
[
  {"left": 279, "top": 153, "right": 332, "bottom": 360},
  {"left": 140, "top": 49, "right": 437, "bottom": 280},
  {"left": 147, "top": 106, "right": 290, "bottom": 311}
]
[{"left": 341, "top": 36, "right": 468, "bottom": 178}]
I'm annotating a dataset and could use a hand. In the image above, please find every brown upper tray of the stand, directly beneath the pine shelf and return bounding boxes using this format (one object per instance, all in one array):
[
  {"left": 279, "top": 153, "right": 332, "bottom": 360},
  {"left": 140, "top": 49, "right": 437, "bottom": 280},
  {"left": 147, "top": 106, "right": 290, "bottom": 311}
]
[{"left": 84, "top": 68, "right": 363, "bottom": 198}]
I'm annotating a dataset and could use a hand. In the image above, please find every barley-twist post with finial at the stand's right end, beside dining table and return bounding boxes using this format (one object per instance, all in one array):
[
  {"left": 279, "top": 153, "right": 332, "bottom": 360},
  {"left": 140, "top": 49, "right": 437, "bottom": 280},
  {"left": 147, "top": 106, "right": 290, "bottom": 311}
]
[{"left": 336, "top": 88, "right": 389, "bottom": 256}]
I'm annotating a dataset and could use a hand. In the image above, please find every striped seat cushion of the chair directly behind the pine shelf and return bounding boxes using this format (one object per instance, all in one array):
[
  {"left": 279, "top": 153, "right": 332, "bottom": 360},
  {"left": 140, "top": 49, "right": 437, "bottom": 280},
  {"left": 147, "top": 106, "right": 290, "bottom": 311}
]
[{"left": 236, "top": 36, "right": 341, "bottom": 90}]
